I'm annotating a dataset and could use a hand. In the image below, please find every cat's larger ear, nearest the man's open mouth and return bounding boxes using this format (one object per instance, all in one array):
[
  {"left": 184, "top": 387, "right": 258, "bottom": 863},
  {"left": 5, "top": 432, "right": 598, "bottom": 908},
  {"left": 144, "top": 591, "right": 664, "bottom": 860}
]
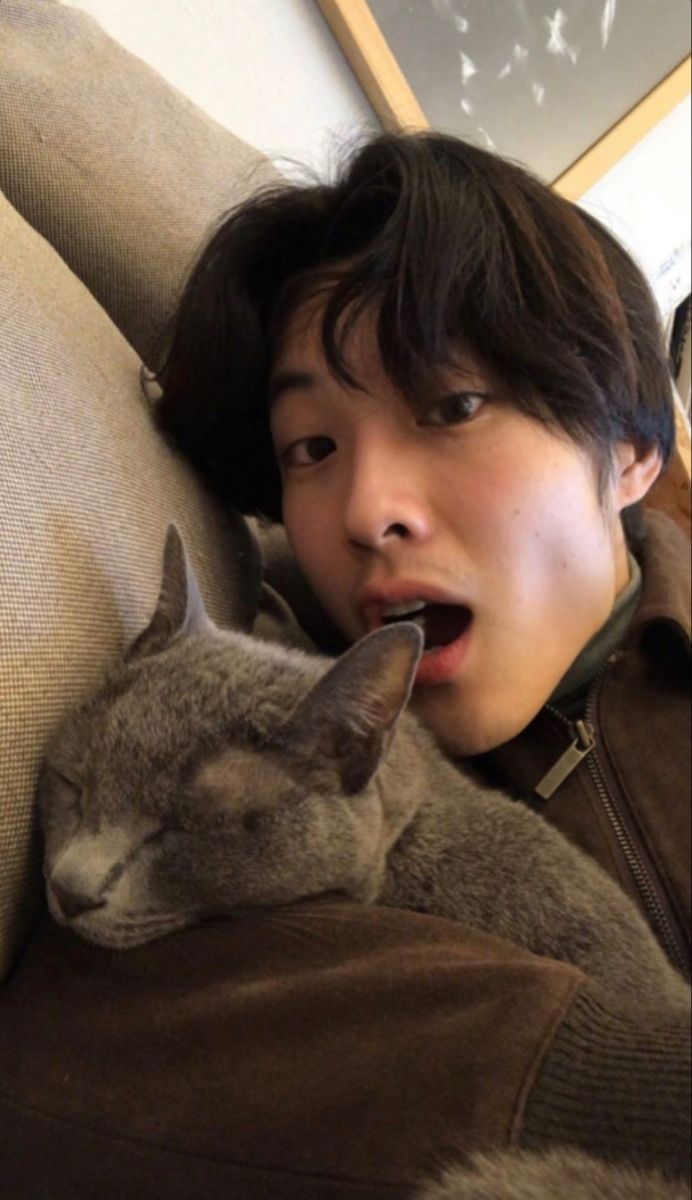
[{"left": 279, "top": 622, "right": 423, "bottom": 796}]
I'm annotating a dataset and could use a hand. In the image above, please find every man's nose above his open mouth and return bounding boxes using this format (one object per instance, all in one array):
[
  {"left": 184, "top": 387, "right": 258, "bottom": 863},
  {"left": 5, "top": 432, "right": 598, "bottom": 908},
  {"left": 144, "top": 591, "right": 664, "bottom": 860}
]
[{"left": 344, "top": 450, "right": 431, "bottom": 550}]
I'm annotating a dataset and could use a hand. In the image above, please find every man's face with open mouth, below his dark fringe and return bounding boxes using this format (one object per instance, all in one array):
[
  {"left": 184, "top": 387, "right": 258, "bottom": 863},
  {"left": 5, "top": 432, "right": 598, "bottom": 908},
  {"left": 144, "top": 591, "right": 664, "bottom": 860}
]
[{"left": 271, "top": 304, "right": 630, "bottom": 755}]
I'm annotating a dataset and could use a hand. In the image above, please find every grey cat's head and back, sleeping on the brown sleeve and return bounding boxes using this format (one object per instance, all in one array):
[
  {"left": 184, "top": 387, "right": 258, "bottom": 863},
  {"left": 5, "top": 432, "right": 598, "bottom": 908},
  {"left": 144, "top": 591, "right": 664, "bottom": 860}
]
[{"left": 40, "top": 528, "right": 688, "bottom": 1008}]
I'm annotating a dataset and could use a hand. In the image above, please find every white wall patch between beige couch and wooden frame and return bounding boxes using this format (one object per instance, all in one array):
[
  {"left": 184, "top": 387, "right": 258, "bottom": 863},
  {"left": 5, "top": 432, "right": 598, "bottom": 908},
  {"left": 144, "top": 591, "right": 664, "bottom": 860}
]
[{"left": 71, "top": 0, "right": 380, "bottom": 172}]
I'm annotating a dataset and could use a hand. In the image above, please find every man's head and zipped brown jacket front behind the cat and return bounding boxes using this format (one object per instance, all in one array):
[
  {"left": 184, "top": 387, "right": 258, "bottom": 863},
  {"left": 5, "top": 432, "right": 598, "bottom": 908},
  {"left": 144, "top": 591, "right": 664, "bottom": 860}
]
[{"left": 153, "top": 134, "right": 690, "bottom": 1171}]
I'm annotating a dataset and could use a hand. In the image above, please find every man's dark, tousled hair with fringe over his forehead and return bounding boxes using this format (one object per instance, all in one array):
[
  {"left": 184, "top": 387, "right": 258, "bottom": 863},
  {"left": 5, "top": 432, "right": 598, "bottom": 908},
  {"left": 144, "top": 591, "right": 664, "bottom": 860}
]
[{"left": 153, "top": 126, "right": 674, "bottom": 530}]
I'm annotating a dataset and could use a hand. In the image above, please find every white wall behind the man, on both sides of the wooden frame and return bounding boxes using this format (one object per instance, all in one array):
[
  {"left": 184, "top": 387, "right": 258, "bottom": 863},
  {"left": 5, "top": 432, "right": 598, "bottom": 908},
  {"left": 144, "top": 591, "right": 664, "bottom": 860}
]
[{"left": 72, "top": 0, "right": 691, "bottom": 313}]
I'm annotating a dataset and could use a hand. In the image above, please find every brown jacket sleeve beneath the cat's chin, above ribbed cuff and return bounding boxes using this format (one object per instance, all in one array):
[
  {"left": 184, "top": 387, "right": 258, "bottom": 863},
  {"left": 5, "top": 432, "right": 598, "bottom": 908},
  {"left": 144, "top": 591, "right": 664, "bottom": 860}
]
[{"left": 0, "top": 901, "right": 580, "bottom": 1200}]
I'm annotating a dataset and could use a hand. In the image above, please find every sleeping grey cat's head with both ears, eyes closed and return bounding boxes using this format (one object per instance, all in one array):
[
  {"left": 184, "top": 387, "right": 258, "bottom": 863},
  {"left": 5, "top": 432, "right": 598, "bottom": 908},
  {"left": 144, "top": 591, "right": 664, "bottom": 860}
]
[{"left": 38, "top": 527, "right": 422, "bottom": 948}]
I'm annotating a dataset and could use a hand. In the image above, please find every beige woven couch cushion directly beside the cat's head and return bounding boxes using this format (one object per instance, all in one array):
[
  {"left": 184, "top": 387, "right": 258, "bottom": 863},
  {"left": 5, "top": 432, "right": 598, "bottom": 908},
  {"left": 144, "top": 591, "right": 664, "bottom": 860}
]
[{"left": 0, "top": 184, "right": 259, "bottom": 977}]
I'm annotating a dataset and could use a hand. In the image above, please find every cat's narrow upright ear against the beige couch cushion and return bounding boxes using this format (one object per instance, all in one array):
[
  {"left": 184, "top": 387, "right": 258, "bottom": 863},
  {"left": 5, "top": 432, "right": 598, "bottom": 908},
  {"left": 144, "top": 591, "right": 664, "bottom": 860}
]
[{"left": 125, "top": 524, "right": 210, "bottom": 662}]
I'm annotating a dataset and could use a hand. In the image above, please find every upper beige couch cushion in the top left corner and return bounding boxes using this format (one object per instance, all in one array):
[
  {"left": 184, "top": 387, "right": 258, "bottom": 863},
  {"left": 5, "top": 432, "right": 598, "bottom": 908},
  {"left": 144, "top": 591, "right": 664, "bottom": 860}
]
[{"left": 0, "top": 0, "right": 278, "bottom": 361}]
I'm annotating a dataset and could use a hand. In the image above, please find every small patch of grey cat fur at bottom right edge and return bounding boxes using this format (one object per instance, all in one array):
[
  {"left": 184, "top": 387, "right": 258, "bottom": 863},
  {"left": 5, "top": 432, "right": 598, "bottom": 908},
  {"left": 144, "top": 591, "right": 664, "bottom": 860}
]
[{"left": 415, "top": 1147, "right": 690, "bottom": 1200}]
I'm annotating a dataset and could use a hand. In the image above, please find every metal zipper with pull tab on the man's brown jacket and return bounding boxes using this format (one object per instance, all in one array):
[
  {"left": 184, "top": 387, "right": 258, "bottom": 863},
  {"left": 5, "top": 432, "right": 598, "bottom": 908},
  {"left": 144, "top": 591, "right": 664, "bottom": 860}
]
[{"left": 535, "top": 661, "right": 687, "bottom": 973}]
